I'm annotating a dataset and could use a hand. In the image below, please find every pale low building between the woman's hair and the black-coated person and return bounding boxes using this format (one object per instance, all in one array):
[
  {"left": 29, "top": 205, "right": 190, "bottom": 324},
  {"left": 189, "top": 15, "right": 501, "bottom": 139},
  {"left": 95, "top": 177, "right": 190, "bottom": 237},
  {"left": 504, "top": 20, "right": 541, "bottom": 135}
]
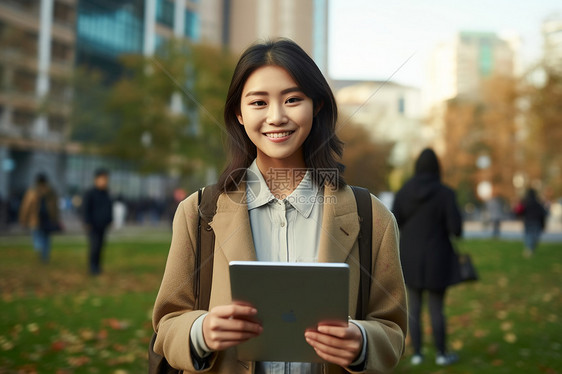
[{"left": 333, "top": 81, "right": 427, "bottom": 167}]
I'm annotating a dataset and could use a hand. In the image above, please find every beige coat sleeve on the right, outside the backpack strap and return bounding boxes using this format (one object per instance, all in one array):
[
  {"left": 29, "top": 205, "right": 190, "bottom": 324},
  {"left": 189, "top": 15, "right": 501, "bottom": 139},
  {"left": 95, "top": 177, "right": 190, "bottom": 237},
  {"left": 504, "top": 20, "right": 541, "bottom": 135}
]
[{"left": 357, "top": 198, "right": 408, "bottom": 373}]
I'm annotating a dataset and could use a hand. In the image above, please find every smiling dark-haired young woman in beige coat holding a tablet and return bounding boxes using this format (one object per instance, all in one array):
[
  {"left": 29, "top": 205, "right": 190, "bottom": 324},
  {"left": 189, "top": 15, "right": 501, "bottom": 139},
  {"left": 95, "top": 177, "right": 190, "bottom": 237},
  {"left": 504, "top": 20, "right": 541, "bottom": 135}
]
[{"left": 153, "top": 39, "right": 407, "bottom": 374}]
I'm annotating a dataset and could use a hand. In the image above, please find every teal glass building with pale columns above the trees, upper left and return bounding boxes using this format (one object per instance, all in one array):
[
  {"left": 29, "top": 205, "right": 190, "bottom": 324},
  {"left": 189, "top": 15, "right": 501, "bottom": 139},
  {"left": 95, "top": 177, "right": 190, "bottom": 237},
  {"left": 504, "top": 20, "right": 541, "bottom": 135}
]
[{"left": 76, "top": 0, "right": 201, "bottom": 81}]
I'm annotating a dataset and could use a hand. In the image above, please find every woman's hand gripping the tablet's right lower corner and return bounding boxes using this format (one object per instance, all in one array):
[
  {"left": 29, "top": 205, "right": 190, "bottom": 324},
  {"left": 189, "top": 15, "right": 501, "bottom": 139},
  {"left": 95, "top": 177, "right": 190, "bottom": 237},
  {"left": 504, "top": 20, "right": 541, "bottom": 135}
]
[{"left": 304, "top": 323, "right": 363, "bottom": 367}]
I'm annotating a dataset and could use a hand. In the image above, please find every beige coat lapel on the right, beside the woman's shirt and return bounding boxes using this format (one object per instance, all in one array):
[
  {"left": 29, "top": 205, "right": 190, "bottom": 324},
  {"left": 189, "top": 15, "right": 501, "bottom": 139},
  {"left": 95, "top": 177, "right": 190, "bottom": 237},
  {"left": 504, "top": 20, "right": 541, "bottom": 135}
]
[{"left": 318, "top": 187, "right": 359, "bottom": 262}]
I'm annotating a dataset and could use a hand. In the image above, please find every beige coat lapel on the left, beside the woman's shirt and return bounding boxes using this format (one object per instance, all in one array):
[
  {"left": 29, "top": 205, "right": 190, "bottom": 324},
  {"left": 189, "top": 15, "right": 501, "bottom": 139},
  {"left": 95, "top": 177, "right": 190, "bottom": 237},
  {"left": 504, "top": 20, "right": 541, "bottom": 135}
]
[{"left": 210, "top": 183, "right": 257, "bottom": 262}]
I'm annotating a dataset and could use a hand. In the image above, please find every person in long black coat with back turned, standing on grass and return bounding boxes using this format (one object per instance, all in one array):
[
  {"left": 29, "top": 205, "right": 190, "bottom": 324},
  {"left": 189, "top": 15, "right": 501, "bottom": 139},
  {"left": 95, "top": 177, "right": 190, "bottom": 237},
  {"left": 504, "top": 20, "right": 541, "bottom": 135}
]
[{"left": 392, "top": 148, "right": 462, "bottom": 365}]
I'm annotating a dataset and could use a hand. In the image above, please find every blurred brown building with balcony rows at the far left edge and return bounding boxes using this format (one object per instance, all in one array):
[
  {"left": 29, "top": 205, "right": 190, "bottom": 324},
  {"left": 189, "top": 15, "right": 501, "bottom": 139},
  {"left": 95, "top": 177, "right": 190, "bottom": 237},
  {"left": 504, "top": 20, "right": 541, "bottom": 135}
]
[{"left": 0, "top": 0, "right": 76, "bottom": 196}]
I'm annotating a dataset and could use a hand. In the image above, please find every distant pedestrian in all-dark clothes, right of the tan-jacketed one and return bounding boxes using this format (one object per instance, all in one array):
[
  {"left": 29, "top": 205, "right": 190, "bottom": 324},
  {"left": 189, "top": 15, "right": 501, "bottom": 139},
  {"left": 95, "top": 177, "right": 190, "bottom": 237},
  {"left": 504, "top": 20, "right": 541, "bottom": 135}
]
[{"left": 82, "top": 169, "right": 113, "bottom": 275}]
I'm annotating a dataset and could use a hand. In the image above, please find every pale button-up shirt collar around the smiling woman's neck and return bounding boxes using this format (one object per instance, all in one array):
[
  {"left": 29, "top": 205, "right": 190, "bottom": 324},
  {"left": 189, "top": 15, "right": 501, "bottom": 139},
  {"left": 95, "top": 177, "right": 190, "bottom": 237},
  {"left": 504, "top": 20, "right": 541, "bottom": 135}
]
[{"left": 246, "top": 160, "right": 319, "bottom": 218}]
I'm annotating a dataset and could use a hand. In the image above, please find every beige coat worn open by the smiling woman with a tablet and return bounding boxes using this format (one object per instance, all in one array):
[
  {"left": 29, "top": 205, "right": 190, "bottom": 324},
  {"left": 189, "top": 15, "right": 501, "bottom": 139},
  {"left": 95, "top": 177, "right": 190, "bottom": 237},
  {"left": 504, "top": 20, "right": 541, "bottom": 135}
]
[{"left": 153, "top": 185, "right": 407, "bottom": 374}]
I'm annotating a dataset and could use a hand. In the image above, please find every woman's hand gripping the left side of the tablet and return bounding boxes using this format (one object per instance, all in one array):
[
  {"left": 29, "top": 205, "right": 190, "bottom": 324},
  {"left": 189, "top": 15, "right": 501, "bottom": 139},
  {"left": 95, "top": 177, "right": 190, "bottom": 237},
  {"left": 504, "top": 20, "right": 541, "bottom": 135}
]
[{"left": 203, "top": 303, "right": 263, "bottom": 351}]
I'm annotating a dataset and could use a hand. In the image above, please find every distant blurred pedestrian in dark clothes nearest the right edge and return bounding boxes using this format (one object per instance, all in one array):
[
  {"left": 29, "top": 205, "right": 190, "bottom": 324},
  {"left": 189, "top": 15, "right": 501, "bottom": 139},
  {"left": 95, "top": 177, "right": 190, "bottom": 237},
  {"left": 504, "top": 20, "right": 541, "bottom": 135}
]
[{"left": 518, "top": 188, "right": 547, "bottom": 257}]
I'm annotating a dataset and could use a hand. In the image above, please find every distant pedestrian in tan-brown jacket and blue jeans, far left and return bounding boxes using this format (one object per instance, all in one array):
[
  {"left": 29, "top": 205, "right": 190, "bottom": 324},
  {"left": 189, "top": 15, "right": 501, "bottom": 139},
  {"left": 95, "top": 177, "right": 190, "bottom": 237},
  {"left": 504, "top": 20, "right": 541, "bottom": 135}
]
[{"left": 19, "top": 173, "right": 61, "bottom": 263}]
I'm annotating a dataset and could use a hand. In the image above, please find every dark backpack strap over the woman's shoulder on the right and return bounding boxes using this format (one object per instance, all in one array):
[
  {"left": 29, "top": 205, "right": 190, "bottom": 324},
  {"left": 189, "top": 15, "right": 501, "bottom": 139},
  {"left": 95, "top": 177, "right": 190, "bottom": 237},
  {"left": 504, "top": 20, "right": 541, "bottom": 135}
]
[{"left": 351, "top": 186, "right": 373, "bottom": 320}]
